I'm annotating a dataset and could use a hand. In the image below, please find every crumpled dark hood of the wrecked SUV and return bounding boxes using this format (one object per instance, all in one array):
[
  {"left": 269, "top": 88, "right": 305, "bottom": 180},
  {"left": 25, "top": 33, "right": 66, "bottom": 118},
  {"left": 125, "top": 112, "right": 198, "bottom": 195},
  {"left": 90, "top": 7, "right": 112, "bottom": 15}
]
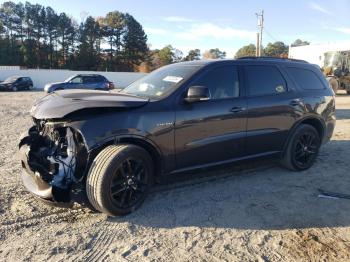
[{"left": 30, "top": 90, "right": 149, "bottom": 119}]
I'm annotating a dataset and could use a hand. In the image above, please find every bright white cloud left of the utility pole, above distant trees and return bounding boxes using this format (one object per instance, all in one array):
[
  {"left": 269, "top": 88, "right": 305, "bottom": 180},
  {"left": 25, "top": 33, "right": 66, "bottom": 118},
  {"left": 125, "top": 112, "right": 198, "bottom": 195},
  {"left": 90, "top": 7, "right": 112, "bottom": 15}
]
[{"left": 176, "top": 23, "right": 256, "bottom": 40}]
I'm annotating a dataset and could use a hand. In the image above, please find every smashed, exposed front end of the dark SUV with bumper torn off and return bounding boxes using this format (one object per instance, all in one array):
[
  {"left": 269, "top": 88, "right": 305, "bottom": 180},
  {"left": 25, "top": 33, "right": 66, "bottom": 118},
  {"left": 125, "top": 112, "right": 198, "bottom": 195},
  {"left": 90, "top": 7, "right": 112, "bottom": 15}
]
[{"left": 19, "top": 127, "right": 75, "bottom": 206}]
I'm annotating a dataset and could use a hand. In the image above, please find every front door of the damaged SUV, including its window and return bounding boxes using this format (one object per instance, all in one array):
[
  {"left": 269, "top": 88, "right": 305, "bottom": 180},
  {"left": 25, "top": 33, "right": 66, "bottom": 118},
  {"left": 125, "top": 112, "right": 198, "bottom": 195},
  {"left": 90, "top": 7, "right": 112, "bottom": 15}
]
[{"left": 174, "top": 65, "right": 246, "bottom": 170}]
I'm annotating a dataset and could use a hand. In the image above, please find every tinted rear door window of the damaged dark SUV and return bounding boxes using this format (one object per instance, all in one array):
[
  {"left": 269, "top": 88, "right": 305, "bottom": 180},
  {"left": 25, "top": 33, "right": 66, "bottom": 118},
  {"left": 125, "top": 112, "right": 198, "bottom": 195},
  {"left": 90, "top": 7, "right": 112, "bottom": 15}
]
[{"left": 245, "top": 66, "right": 287, "bottom": 96}]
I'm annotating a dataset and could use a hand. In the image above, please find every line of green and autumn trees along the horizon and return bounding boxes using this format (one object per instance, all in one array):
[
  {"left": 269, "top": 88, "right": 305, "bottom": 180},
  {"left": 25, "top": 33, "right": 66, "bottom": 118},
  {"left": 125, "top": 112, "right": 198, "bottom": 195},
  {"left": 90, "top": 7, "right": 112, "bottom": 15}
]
[{"left": 0, "top": 2, "right": 309, "bottom": 72}]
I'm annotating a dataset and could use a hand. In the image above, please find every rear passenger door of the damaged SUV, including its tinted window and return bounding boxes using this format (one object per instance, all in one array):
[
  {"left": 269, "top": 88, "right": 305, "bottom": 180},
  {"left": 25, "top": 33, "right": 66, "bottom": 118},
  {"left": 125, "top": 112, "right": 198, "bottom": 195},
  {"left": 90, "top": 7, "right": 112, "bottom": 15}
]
[{"left": 243, "top": 64, "right": 302, "bottom": 155}]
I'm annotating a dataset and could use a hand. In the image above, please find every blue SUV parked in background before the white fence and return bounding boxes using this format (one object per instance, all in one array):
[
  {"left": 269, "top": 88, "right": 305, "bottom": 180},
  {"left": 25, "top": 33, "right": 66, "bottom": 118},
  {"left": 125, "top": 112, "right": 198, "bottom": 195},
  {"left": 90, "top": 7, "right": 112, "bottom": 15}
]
[{"left": 44, "top": 74, "right": 114, "bottom": 93}]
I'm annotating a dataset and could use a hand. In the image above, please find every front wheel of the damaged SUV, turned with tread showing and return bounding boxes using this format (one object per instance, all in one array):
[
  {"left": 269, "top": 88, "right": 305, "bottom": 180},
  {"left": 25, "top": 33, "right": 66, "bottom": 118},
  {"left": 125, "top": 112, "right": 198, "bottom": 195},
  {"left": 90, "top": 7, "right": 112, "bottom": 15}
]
[{"left": 86, "top": 144, "right": 153, "bottom": 216}]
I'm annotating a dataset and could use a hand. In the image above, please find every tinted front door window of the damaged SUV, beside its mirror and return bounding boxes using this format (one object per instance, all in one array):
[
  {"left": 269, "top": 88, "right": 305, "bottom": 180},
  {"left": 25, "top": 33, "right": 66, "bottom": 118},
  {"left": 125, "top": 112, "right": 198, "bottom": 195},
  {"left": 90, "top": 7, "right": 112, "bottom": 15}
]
[{"left": 192, "top": 66, "right": 239, "bottom": 99}]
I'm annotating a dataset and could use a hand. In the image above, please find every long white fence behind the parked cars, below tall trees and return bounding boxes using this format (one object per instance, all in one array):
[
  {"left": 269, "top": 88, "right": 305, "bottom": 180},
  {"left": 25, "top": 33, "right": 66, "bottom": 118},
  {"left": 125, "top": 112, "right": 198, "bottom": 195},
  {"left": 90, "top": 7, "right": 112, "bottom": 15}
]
[{"left": 0, "top": 67, "right": 145, "bottom": 89}]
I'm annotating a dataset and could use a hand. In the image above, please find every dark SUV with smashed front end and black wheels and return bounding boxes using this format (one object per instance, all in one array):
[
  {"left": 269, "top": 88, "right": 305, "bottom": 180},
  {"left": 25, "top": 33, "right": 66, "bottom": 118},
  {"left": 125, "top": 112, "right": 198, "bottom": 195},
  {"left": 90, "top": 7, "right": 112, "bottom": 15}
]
[{"left": 19, "top": 58, "right": 335, "bottom": 215}]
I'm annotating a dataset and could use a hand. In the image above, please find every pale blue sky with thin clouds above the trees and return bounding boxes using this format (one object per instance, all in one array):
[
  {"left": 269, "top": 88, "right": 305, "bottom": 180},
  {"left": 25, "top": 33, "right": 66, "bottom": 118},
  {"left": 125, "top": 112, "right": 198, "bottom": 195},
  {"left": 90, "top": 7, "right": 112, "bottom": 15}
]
[{"left": 4, "top": 0, "right": 350, "bottom": 57}]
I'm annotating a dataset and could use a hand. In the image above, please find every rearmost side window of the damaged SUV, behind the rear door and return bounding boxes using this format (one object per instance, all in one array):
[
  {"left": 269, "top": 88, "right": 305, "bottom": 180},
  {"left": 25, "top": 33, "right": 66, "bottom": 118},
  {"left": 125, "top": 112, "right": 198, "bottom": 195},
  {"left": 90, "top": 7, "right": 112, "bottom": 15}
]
[{"left": 287, "top": 67, "right": 325, "bottom": 89}]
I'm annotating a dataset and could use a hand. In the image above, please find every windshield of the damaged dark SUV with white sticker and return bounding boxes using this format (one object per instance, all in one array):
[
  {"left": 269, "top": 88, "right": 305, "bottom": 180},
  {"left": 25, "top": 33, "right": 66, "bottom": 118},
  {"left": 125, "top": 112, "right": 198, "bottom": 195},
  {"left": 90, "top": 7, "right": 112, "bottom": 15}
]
[{"left": 121, "top": 64, "right": 199, "bottom": 99}]
